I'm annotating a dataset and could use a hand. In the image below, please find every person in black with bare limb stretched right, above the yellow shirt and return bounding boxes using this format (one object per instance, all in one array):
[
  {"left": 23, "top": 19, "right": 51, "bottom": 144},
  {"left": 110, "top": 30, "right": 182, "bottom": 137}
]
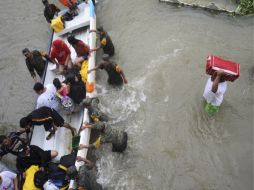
[{"left": 16, "top": 145, "right": 58, "bottom": 172}]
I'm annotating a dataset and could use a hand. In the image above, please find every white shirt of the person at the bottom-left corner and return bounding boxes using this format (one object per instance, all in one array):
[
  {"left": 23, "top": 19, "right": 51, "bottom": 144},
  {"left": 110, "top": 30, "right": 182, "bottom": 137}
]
[{"left": 0, "top": 171, "right": 17, "bottom": 190}]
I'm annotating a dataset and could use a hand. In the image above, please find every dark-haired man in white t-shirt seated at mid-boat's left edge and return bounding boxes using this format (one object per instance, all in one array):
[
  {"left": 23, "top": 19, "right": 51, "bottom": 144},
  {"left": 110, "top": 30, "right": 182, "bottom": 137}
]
[{"left": 34, "top": 82, "right": 60, "bottom": 111}]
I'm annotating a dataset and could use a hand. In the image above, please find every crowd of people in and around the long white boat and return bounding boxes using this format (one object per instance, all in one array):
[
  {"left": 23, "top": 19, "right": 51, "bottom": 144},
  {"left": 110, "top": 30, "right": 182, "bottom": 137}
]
[{"left": 0, "top": 0, "right": 128, "bottom": 190}]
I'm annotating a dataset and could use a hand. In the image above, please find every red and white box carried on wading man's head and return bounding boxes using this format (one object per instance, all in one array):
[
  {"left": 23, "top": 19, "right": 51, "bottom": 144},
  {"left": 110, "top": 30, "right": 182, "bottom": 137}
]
[{"left": 206, "top": 55, "right": 240, "bottom": 82}]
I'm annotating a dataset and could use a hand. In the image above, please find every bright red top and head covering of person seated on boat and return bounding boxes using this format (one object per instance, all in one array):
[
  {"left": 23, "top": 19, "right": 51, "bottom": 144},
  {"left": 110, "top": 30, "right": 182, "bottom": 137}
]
[{"left": 50, "top": 40, "right": 71, "bottom": 65}]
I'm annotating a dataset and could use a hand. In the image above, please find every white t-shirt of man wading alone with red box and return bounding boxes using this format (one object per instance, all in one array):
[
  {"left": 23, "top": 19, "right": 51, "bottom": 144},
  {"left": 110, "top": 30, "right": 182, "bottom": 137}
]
[{"left": 203, "top": 77, "right": 227, "bottom": 106}]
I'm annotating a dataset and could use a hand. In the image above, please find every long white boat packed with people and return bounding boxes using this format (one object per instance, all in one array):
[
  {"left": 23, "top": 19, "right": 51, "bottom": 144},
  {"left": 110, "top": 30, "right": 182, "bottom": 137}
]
[{"left": 31, "top": 0, "right": 96, "bottom": 187}]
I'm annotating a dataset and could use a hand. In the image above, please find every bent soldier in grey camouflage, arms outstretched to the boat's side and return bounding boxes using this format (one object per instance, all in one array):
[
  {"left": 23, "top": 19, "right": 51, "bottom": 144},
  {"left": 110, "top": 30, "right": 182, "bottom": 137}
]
[{"left": 79, "top": 121, "right": 128, "bottom": 152}]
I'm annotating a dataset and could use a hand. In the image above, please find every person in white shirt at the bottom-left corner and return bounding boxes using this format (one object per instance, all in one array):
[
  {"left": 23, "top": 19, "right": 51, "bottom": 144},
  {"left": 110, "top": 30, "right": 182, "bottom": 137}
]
[{"left": 0, "top": 171, "right": 19, "bottom": 190}]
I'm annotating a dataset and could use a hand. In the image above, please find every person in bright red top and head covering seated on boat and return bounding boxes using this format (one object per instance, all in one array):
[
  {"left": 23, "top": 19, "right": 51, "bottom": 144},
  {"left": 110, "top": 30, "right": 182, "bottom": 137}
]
[{"left": 50, "top": 39, "right": 72, "bottom": 74}]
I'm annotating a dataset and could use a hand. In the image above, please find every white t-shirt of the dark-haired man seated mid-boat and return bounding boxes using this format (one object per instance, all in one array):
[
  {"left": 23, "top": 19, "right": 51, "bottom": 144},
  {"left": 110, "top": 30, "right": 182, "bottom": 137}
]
[{"left": 36, "top": 84, "right": 60, "bottom": 110}]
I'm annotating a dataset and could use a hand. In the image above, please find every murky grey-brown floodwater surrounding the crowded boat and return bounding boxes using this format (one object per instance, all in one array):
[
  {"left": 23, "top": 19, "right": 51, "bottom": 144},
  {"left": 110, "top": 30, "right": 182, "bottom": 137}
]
[{"left": 0, "top": 0, "right": 254, "bottom": 190}]
